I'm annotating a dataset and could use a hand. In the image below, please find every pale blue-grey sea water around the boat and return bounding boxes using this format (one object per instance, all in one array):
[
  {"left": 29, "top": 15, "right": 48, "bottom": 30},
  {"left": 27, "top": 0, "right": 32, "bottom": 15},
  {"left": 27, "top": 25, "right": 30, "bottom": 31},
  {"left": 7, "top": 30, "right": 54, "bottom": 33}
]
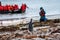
[{"left": 0, "top": 0, "right": 60, "bottom": 19}]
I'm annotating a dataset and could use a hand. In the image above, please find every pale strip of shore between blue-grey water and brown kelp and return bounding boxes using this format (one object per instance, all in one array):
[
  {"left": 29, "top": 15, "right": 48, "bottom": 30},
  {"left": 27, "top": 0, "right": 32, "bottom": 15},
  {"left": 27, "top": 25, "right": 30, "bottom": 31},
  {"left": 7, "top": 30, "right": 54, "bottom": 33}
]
[{"left": 0, "top": 14, "right": 60, "bottom": 26}]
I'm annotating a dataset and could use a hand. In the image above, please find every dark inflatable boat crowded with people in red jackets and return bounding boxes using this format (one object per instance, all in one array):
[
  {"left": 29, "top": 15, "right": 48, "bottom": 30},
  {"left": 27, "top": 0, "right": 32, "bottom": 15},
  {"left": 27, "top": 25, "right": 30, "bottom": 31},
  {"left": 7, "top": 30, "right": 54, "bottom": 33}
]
[{"left": 0, "top": 2, "right": 28, "bottom": 14}]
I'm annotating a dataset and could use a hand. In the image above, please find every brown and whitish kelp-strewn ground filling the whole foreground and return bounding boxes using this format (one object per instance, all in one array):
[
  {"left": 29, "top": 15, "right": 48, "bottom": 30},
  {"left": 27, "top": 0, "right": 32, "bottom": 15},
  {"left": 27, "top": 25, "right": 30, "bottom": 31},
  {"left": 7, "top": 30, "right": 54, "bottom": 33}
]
[{"left": 0, "top": 19, "right": 60, "bottom": 40}]
